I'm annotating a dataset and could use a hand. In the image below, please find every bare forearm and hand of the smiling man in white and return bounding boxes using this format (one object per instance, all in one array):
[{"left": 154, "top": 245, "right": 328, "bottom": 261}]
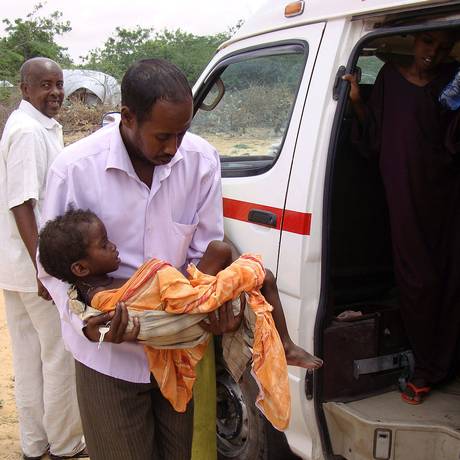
[{"left": 11, "top": 200, "right": 51, "bottom": 300}]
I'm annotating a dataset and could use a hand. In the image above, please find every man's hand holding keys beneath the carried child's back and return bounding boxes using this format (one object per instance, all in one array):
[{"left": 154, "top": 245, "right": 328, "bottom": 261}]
[{"left": 83, "top": 302, "right": 141, "bottom": 343}]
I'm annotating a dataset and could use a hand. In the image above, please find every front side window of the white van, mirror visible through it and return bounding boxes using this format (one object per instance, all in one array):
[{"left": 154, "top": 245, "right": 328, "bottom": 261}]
[{"left": 191, "top": 46, "right": 305, "bottom": 177}]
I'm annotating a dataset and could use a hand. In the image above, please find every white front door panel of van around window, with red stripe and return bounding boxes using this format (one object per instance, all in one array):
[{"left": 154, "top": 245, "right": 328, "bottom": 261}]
[{"left": 195, "top": 24, "right": 324, "bottom": 273}]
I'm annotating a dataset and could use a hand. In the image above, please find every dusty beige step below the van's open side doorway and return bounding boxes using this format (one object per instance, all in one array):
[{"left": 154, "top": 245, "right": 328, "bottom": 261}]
[{"left": 323, "top": 390, "right": 460, "bottom": 460}]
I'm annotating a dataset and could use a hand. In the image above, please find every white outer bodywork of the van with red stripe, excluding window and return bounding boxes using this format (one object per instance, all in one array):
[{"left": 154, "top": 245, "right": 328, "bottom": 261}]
[{"left": 190, "top": 0, "right": 460, "bottom": 460}]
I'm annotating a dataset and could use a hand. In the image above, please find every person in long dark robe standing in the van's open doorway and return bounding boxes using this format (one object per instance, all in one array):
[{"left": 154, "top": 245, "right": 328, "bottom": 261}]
[{"left": 344, "top": 31, "right": 460, "bottom": 404}]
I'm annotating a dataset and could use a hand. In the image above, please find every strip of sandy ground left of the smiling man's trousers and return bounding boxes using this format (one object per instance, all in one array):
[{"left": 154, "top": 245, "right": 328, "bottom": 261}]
[{"left": 0, "top": 291, "right": 21, "bottom": 460}]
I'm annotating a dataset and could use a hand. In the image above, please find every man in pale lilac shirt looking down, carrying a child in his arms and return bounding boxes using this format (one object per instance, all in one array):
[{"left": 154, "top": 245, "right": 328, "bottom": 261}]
[{"left": 42, "top": 59, "right": 240, "bottom": 460}]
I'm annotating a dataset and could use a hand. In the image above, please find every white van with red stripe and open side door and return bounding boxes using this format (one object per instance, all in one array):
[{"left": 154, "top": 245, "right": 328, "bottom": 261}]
[{"left": 192, "top": 0, "right": 460, "bottom": 460}]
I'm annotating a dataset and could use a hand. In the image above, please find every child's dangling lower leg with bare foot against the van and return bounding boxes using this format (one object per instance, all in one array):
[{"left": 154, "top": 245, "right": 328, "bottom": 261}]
[{"left": 260, "top": 270, "right": 323, "bottom": 369}]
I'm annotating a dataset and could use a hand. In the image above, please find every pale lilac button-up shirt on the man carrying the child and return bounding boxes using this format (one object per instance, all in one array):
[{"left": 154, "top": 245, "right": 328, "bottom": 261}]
[{"left": 41, "top": 124, "right": 223, "bottom": 383}]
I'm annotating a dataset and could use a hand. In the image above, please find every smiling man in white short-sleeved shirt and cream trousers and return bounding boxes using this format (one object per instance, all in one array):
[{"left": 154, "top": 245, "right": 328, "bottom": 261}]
[{"left": 0, "top": 58, "right": 87, "bottom": 460}]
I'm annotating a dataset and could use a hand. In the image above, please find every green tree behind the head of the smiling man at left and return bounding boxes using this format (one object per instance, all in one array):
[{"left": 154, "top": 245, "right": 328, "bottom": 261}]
[{"left": 0, "top": 3, "right": 72, "bottom": 80}]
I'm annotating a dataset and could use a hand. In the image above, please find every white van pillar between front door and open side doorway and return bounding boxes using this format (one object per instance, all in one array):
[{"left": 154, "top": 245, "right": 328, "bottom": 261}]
[{"left": 277, "top": 19, "right": 362, "bottom": 458}]
